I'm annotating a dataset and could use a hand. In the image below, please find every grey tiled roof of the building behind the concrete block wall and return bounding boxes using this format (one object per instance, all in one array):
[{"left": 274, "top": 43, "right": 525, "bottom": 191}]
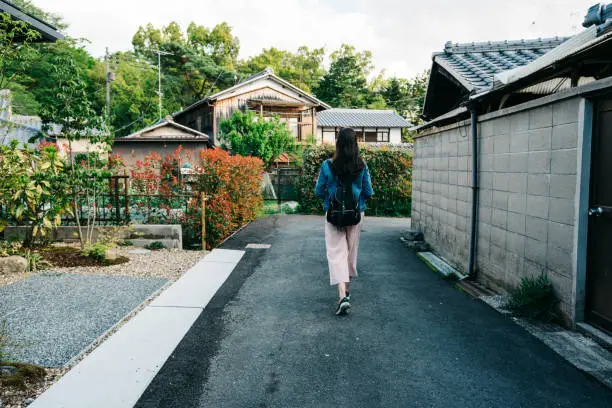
[{"left": 433, "top": 37, "right": 570, "bottom": 92}]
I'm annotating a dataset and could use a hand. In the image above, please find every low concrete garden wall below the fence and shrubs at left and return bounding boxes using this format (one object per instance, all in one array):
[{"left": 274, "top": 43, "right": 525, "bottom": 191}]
[{"left": 4, "top": 224, "right": 183, "bottom": 248}]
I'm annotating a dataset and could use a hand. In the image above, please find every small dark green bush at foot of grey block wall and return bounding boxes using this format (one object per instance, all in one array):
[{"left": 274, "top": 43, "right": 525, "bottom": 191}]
[{"left": 507, "top": 274, "right": 559, "bottom": 322}]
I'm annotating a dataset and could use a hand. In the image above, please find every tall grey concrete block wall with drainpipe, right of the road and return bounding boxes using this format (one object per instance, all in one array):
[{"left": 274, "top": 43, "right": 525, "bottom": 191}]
[{"left": 413, "top": 98, "right": 579, "bottom": 321}]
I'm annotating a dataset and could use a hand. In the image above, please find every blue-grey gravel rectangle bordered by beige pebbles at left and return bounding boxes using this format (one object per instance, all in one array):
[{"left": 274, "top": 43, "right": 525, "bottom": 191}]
[{"left": 0, "top": 274, "right": 167, "bottom": 367}]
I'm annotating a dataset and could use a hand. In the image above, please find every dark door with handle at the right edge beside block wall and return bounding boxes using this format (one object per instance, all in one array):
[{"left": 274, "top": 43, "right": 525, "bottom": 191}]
[{"left": 586, "top": 100, "right": 612, "bottom": 332}]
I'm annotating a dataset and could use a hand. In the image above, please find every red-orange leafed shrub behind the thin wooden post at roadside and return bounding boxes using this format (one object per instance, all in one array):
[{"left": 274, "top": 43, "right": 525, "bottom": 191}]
[{"left": 115, "top": 147, "right": 263, "bottom": 248}]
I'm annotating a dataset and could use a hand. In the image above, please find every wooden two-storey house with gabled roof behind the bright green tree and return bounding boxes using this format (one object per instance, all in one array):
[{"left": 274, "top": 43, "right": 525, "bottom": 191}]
[{"left": 174, "top": 68, "right": 330, "bottom": 145}]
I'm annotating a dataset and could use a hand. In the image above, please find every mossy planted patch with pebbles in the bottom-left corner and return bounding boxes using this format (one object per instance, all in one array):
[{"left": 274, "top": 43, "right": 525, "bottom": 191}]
[{"left": 0, "top": 363, "right": 66, "bottom": 408}]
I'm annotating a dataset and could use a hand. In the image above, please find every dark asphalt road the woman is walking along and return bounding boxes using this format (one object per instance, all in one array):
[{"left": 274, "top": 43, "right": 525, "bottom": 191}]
[{"left": 137, "top": 216, "right": 612, "bottom": 408}]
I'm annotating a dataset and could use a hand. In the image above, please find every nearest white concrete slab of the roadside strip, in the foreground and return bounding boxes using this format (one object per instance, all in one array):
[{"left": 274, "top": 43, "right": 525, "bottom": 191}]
[{"left": 30, "top": 307, "right": 202, "bottom": 408}]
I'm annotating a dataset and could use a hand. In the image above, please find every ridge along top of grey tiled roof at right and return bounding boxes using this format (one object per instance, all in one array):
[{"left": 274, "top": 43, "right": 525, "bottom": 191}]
[{"left": 434, "top": 36, "right": 571, "bottom": 56}]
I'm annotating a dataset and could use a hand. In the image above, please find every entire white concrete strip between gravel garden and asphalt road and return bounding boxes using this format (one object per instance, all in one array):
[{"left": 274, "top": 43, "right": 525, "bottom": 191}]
[{"left": 30, "top": 249, "right": 244, "bottom": 408}]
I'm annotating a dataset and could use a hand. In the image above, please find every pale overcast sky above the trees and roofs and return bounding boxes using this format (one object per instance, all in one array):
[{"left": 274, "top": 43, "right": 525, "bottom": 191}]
[{"left": 33, "top": 0, "right": 595, "bottom": 77}]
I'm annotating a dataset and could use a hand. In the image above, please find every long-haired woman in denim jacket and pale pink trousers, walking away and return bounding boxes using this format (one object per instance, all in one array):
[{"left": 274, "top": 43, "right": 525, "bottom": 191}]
[{"left": 315, "top": 128, "right": 373, "bottom": 315}]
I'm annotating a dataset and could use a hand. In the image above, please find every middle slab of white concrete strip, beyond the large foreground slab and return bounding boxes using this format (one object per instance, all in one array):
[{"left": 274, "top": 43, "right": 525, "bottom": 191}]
[{"left": 150, "top": 262, "right": 236, "bottom": 308}]
